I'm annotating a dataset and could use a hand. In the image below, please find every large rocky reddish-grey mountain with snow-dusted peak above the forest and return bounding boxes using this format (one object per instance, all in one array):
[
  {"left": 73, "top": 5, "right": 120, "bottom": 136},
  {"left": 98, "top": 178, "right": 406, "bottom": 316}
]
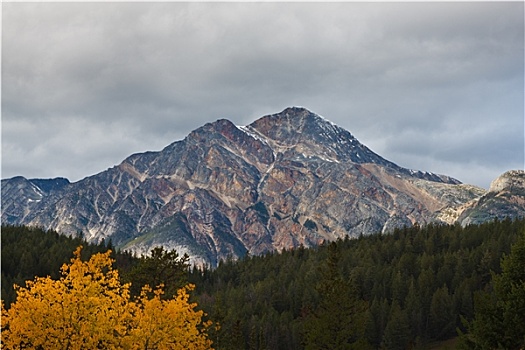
[{"left": 2, "top": 107, "right": 522, "bottom": 266}]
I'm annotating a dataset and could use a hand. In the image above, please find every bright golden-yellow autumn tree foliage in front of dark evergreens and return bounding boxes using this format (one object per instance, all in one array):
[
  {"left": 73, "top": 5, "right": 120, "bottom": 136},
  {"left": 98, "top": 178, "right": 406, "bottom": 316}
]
[{"left": 1, "top": 247, "right": 211, "bottom": 350}]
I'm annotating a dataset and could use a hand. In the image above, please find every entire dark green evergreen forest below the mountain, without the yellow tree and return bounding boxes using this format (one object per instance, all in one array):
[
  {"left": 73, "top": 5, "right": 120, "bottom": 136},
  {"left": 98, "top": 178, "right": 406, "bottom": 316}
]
[{"left": 1, "top": 219, "right": 525, "bottom": 349}]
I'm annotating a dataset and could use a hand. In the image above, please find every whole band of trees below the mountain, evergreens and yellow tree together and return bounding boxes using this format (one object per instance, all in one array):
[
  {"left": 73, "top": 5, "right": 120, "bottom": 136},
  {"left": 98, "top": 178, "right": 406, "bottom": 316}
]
[{"left": 2, "top": 220, "right": 525, "bottom": 349}]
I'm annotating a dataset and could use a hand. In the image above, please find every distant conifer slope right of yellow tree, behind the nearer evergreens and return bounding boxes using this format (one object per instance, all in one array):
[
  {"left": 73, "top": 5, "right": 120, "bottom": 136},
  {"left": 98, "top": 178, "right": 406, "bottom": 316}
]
[{"left": 190, "top": 220, "right": 525, "bottom": 349}]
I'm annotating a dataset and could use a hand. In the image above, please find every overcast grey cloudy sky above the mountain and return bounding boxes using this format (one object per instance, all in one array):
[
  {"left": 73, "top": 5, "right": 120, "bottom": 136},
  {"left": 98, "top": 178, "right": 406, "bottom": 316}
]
[{"left": 1, "top": 2, "right": 525, "bottom": 188}]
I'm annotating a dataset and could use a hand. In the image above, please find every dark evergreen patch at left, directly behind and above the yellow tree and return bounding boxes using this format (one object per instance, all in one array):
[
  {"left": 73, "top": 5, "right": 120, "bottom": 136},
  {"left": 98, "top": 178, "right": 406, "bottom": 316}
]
[{"left": 1, "top": 225, "right": 189, "bottom": 308}]
